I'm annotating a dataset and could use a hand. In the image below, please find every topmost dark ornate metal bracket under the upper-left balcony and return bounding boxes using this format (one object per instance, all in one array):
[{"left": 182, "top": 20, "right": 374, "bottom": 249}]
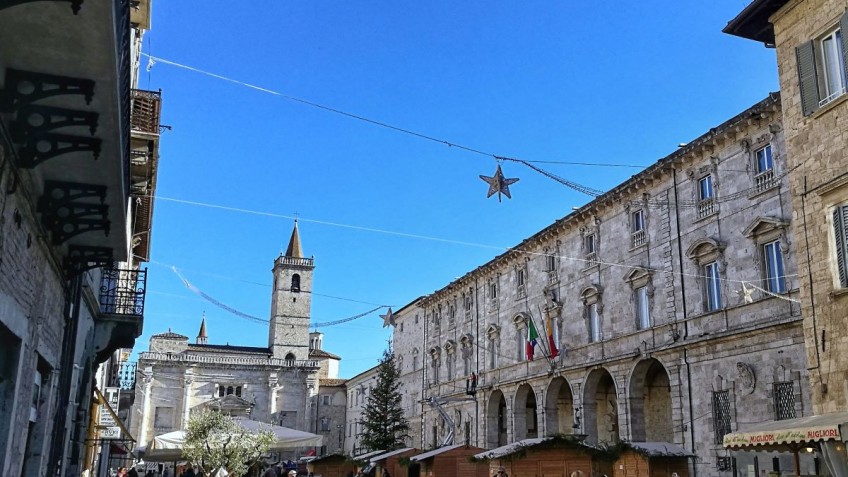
[{"left": 0, "top": 68, "right": 94, "bottom": 112}]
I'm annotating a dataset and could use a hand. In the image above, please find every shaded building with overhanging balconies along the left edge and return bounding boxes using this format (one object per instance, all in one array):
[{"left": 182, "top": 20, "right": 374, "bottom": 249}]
[{"left": 0, "top": 0, "right": 161, "bottom": 476}]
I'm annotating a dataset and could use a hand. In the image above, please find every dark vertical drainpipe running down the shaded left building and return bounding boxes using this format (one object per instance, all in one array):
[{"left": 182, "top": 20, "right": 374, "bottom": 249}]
[{"left": 47, "top": 270, "right": 84, "bottom": 475}]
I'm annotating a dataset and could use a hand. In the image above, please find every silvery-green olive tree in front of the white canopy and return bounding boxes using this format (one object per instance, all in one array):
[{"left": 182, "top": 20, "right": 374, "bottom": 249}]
[{"left": 183, "top": 409, "right": 274, "bottom": 476}]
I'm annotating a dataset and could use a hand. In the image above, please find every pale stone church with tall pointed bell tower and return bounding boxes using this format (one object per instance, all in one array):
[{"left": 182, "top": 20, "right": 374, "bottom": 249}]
[{"left": 134, "top": 224, "right": 344, "bottom": 456}]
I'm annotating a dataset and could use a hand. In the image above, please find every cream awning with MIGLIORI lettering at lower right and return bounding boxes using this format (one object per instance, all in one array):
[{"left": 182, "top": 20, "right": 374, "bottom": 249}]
[{"left": 723, "top": 412, "right": 848, "bottom": 450}]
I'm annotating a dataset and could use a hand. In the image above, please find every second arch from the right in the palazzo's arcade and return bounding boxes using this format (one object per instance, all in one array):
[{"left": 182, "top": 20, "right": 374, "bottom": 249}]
[{"left": 583, "top": 368, "right": 619, "bottom": 442}]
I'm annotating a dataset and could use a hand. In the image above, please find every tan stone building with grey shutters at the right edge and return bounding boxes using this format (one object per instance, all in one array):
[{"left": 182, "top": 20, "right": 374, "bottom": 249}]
[{"left": 724, "top": 0, "right": 848, "bottom": 413}]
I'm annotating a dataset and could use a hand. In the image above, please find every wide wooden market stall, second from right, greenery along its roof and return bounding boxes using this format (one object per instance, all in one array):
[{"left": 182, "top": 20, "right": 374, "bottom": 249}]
[{"left": 470, "top": 436, "right": 596, "bottom": 477}]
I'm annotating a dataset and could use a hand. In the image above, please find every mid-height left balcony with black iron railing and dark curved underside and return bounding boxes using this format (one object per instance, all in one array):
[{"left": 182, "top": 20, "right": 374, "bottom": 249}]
[{"left": 95, "top": 268, "right": 147, "bottom": 363}]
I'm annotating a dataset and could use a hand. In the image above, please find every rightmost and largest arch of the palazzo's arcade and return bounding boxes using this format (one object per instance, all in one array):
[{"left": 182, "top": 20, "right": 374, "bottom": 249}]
[{"left": 630, "top": 358, "right": 674, "bottom": 442}]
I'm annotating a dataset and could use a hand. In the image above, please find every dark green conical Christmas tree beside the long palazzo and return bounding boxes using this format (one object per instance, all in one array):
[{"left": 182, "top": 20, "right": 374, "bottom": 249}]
[{"left": 362, "top": 344, "right": 409, "bottom": 450}]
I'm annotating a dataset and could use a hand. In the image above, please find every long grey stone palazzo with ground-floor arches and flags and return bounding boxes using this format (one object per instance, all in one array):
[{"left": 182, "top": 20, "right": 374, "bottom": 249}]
[{"left": 393, "top": 94, "right": 812, "bottom": 475}]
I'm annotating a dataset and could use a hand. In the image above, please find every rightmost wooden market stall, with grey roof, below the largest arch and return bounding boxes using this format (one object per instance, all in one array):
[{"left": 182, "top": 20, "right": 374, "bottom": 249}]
[{"left": 612, "top": 442, "right": 695, "bottom": 477}]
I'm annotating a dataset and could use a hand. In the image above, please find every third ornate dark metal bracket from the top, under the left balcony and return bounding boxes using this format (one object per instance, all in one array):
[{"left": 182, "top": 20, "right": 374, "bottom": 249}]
[{"left": 38, "top": 181, "right": 111, "bottom": 245}]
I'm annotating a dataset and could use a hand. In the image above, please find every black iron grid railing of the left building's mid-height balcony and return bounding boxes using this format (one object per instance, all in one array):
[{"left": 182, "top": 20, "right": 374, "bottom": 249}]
[{"left": 100, "top": 268, "right": 147, "bottom": 317}]
